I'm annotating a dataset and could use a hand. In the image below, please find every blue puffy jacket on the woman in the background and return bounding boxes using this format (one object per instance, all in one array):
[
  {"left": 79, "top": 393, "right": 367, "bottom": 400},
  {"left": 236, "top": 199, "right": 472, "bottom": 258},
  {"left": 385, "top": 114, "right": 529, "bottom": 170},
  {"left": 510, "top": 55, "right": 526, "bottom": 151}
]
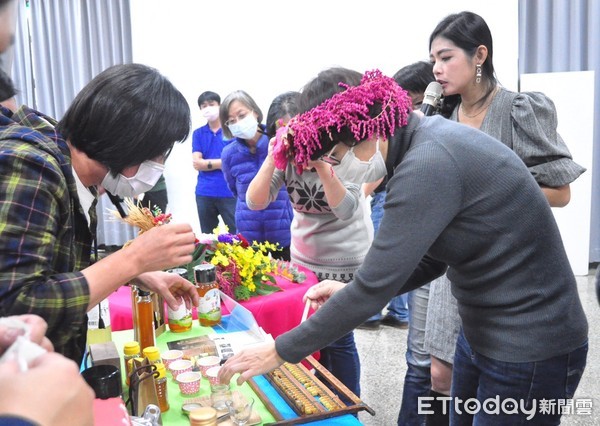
[{"left": 221, "top": 131, "right": 293, "bottom": 247}]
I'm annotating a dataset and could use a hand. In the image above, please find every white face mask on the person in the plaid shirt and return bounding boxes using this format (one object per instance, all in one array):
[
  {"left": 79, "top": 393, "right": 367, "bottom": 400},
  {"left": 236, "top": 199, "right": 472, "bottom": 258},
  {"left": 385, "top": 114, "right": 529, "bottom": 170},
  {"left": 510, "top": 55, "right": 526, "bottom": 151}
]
[{"left": 102, "top": 160, "right": 165, "bottom": 197}]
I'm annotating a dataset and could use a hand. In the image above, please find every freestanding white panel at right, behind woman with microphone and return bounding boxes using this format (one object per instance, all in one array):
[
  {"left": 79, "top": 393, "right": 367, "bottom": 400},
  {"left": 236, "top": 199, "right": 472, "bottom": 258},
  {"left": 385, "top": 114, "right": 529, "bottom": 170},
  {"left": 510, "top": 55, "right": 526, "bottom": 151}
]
[{"left": 521, "top": 71, "right": 594, "bottom": 275}]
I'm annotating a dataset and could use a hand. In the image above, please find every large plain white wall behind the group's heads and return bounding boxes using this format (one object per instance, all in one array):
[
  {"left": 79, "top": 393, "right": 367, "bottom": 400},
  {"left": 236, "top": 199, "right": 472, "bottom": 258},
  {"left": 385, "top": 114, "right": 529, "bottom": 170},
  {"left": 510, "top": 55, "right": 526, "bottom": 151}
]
[{"left": 131, "top": 0, "right": 518, "bottom": 232}]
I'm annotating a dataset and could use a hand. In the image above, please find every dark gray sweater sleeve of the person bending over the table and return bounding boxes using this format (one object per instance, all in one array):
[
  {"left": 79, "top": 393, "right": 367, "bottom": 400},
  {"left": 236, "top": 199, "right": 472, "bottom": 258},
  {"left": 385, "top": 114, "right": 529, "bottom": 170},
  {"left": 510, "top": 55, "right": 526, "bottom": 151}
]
[{"left": 275, "top": 143, "right": 463, "bottom": 362}]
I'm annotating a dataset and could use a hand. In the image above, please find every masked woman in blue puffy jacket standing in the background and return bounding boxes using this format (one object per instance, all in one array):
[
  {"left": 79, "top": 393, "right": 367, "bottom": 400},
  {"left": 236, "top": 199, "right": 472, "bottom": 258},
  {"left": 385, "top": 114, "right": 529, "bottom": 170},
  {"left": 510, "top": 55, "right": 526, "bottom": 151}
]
[{"left": 219, "top": 90, "right": 293, "bottom": 260}]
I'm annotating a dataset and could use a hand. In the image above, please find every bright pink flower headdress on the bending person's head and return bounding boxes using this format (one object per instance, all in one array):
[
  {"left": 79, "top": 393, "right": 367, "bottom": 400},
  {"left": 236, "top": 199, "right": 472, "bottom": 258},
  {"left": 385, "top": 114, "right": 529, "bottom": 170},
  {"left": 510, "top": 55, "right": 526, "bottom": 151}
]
[{"left": 273, "top": 70, "right": 412, "bottom": 173}]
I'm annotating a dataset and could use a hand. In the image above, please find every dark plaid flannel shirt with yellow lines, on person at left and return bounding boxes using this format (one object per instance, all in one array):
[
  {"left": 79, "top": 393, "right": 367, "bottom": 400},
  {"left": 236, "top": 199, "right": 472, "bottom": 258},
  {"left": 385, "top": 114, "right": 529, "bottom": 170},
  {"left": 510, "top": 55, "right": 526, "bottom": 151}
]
[{"left": 0, "top": 107, "right": 96, "bottom": 362}]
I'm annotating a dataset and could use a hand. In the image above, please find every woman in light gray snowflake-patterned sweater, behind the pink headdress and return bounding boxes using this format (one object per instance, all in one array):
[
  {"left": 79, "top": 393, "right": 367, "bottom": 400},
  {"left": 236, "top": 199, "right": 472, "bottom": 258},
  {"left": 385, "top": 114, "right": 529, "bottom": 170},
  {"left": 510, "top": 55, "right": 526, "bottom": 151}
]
[{"left": 246, "top": 72, "right": 387, "bottom": 396}]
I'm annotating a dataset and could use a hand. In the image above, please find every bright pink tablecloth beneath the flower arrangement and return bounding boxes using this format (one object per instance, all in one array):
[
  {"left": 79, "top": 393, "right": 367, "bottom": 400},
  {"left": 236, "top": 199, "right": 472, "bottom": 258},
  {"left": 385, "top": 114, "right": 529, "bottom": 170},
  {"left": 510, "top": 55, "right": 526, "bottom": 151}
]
[{"left": 108, "top": 267, "right": 318, "bottom": 338}]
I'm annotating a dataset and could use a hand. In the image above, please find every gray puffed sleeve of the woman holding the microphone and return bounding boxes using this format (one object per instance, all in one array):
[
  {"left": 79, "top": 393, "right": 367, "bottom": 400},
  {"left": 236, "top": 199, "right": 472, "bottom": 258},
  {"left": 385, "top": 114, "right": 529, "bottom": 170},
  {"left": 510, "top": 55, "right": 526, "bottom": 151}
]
[{"left": 511, "top": 92, "right": 585, "bottom": 187}]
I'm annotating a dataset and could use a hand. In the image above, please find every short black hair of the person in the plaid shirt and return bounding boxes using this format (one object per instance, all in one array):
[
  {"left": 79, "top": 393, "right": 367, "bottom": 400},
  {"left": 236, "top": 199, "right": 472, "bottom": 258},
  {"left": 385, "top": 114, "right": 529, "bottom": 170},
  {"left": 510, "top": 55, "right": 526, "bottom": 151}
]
[{"left": 56, "top": 64, "right": 191, "bottom": 174}]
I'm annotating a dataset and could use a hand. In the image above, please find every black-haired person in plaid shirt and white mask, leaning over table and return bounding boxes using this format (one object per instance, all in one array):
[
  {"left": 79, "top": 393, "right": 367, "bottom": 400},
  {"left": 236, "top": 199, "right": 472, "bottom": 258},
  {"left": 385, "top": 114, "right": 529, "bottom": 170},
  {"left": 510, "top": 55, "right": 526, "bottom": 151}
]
[{"left": 0, "top": 64, "right": 198, "bottom": 364}]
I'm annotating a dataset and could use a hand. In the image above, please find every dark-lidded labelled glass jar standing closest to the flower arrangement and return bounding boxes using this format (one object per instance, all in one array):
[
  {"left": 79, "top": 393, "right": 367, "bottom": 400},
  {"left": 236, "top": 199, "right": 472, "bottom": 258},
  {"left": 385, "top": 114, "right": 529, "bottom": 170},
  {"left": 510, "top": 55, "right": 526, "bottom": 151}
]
[{"left": 194, "top": 263, "right": 221, "bottom": 327}]
